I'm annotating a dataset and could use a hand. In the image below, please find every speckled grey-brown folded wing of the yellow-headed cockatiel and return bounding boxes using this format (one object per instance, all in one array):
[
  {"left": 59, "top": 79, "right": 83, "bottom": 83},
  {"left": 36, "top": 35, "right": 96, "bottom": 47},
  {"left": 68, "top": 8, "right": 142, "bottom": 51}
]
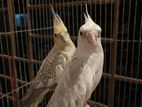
[{"left": 21, "top": 48, "right": 67, "bottom": 105}]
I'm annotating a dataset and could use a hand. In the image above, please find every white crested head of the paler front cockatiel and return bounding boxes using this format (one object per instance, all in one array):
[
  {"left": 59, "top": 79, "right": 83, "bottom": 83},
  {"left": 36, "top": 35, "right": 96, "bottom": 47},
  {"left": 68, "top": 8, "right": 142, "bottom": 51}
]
[{"left": 78, "top": 5, "right": 101, "bottom": 46}]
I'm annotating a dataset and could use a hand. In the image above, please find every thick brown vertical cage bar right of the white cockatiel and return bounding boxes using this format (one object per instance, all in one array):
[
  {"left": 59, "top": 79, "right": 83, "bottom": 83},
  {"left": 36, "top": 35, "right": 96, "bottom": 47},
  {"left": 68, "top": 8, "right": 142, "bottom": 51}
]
[{"left": 108, "top": 0, "right": 120, "bottom": 107}]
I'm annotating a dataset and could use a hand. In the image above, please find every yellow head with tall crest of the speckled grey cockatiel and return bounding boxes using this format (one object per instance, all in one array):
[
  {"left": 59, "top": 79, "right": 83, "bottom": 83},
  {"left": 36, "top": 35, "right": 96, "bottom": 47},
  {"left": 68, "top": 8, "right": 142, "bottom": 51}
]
[{"left": 51, "top": 5, "right": 72, "bottom": 48}]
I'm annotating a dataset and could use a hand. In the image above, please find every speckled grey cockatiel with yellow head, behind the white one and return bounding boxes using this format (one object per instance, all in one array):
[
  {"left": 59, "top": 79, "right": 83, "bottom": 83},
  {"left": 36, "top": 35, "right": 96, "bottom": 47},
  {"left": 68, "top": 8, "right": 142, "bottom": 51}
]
[{"left": 21, "top": 6, "right": 76, "bottom": 107}]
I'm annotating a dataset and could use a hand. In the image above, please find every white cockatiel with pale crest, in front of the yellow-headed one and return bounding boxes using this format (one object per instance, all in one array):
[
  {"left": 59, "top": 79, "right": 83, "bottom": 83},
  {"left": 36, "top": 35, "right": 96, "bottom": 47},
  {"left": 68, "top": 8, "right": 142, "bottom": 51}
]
[{"left": 47, "top": 5, "right": 104, "bottom": 107}]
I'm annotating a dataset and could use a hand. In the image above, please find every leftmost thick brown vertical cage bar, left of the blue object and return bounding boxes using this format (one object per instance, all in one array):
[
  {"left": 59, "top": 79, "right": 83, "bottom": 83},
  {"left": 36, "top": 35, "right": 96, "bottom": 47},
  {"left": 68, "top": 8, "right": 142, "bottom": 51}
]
[{"left": 7, "top": 0, "right": 19, "bottom": 107}]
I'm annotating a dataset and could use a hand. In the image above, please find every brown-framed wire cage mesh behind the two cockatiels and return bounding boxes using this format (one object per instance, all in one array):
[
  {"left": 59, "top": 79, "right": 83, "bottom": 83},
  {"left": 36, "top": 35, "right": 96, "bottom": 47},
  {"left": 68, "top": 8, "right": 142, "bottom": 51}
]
[{"left": 0, "top": 0, "right": 142, "bottom": 107}]
